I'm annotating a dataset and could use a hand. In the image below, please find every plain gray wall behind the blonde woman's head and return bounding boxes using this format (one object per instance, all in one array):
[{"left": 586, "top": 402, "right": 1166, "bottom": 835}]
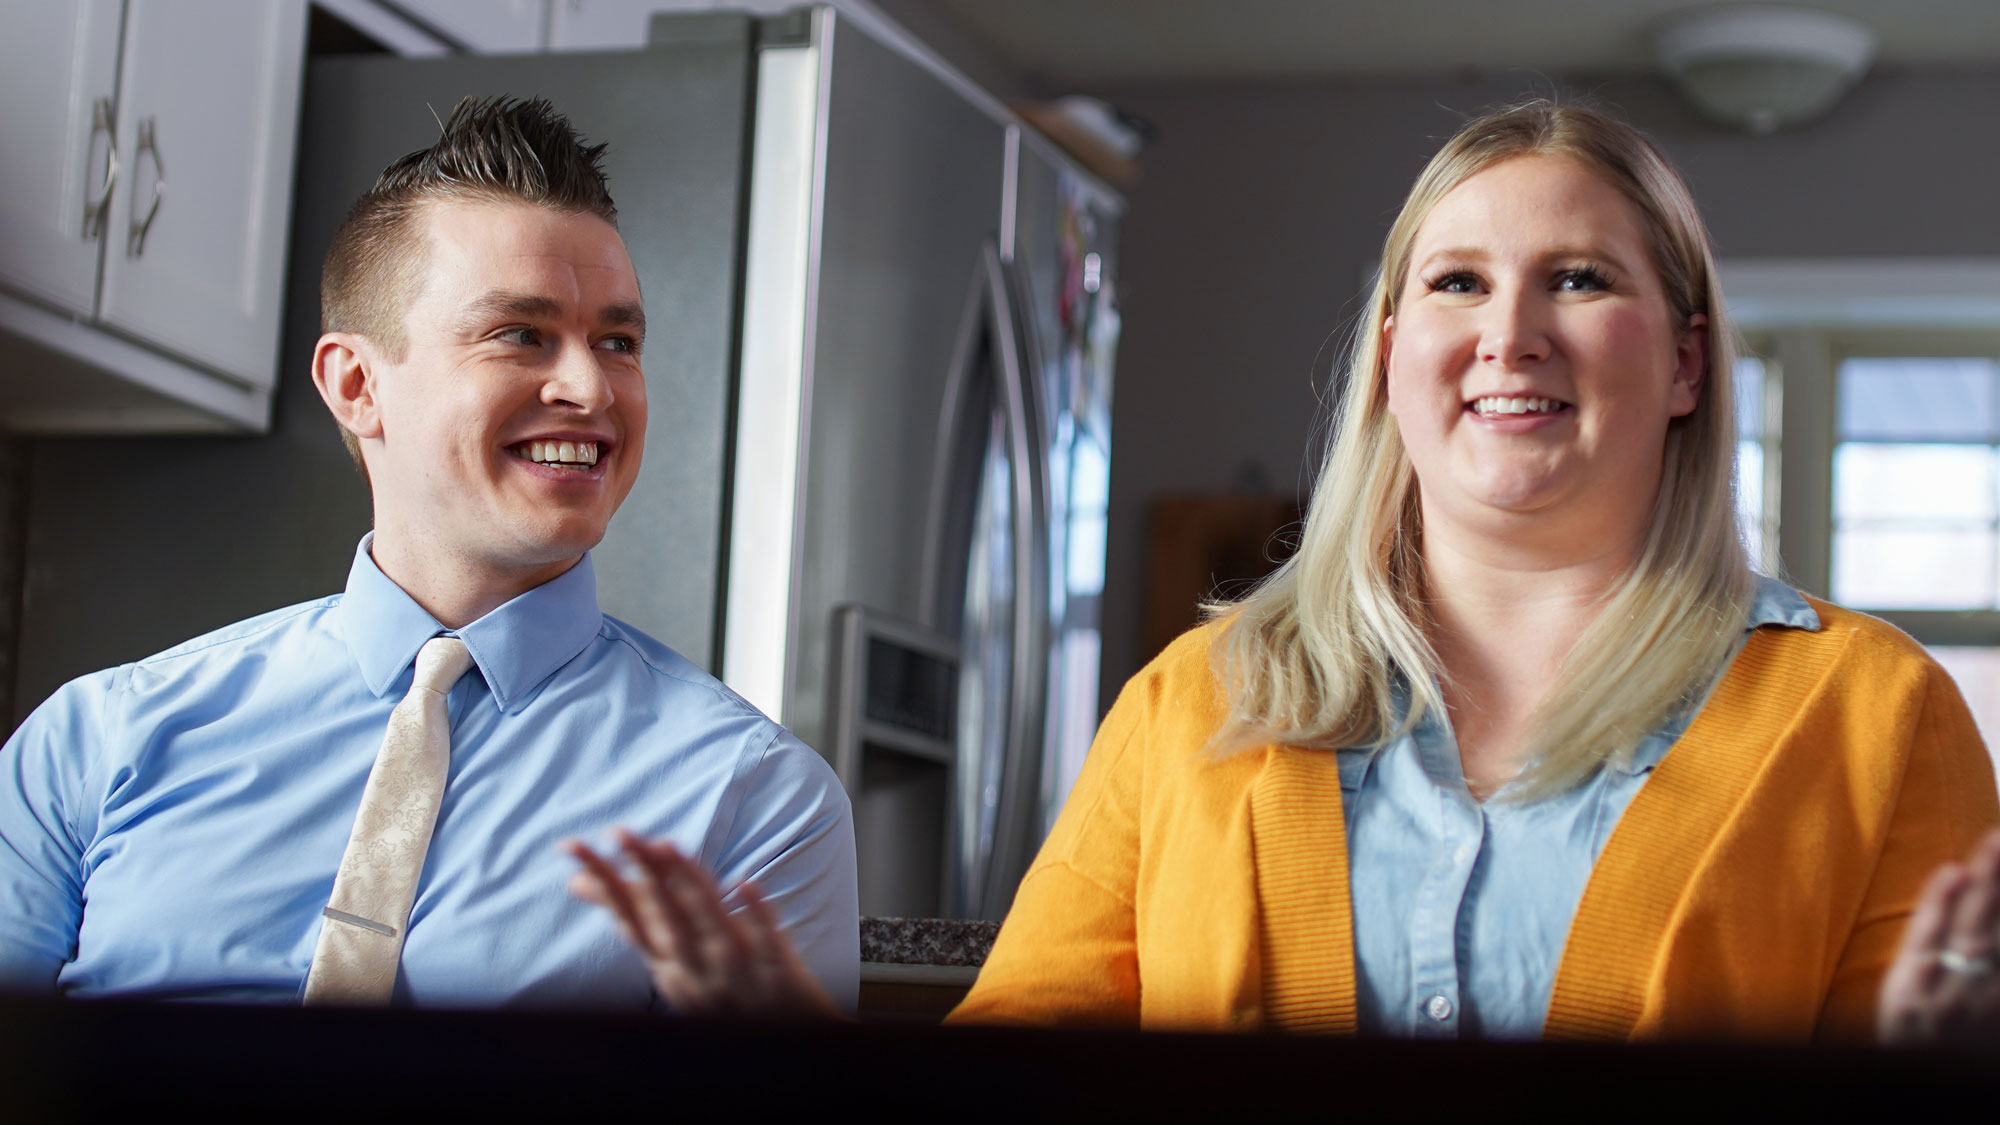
[{"left": 1094, "top": 70, "right": 2000, "bottom": 705}]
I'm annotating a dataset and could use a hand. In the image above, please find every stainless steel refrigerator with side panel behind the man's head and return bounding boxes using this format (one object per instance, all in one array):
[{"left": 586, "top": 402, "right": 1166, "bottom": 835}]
[{"left": 312, "top": 8, "right": 1122, "bottom": 919}]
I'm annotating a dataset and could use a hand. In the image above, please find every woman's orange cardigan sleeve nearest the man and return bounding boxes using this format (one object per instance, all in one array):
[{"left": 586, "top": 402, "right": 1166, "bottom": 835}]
[{"left": 948, "top": 664, "right": 1150, "bottom": 1027}]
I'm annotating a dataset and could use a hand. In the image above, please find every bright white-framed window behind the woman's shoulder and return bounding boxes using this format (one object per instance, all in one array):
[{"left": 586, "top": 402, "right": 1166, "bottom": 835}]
[{"left": 1736, "top": 324, "right": 2000, "bottom": 759}]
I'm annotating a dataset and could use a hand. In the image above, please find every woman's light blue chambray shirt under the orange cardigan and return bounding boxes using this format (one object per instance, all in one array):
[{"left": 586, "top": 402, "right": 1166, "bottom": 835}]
[{"left": 1340, "top": 575, "right": 1820, "bottom": 1039}]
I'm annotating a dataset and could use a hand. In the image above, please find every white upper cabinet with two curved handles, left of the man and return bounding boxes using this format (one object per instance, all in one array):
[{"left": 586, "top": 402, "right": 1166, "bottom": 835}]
[{"left": 0, "top": 0, "right": 306, "bottom": 432}]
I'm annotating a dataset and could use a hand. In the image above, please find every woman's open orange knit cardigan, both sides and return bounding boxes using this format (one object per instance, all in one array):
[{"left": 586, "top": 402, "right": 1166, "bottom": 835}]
[{"left": 952, "top": 601, "right": 2000, "bottom": 1041}]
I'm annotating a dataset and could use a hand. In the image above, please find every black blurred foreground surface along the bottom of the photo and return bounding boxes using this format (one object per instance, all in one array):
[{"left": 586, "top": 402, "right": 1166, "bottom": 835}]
[{"left": 0, "top": 1001, "right": 2000, "bottom": 1123}]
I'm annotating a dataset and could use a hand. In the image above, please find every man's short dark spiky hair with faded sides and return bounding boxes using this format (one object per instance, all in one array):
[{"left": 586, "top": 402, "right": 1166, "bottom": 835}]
[{"left": 320, "top": 98, "right": 618, "bottom": 464}]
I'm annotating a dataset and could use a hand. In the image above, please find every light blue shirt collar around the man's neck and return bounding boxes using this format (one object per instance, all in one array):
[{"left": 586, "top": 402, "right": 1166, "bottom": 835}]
[{"left": 340, "top": 532, "right": 604, "bottom": 711}]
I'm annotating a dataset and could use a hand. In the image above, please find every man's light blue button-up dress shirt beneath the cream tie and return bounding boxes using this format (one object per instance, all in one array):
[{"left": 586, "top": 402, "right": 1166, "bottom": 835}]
[{"left": 0, "top": 536, "right": 860, "bottom": 1011}]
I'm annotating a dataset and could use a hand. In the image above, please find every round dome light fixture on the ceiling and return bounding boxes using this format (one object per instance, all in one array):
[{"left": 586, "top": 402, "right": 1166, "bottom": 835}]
[{"left": 1654, "top": 4, "right": 1876, "bottom": 134}]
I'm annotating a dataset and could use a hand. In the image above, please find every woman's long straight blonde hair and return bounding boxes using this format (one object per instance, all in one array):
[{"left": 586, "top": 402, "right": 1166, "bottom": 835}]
[{"left": 1208, "top": 100, "right": 1752, "bottom": 799}]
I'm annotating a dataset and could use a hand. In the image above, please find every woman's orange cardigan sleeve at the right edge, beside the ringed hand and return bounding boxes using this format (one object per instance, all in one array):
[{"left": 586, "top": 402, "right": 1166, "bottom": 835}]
[{"left": 1818, "top": 663, "right": 2000, "bottom": 1043}]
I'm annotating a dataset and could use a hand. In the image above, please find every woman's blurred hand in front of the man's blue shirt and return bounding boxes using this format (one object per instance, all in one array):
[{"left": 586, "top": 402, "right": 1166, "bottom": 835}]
[{"left": 562, "top": 829, "right": 842, "bottom": 1019}]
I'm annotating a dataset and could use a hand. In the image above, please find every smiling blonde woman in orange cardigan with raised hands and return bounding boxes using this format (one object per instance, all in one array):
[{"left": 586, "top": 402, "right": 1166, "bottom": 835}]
[{"left": 580, "top": 102, "right": 2000, "bottom": 1039}]
